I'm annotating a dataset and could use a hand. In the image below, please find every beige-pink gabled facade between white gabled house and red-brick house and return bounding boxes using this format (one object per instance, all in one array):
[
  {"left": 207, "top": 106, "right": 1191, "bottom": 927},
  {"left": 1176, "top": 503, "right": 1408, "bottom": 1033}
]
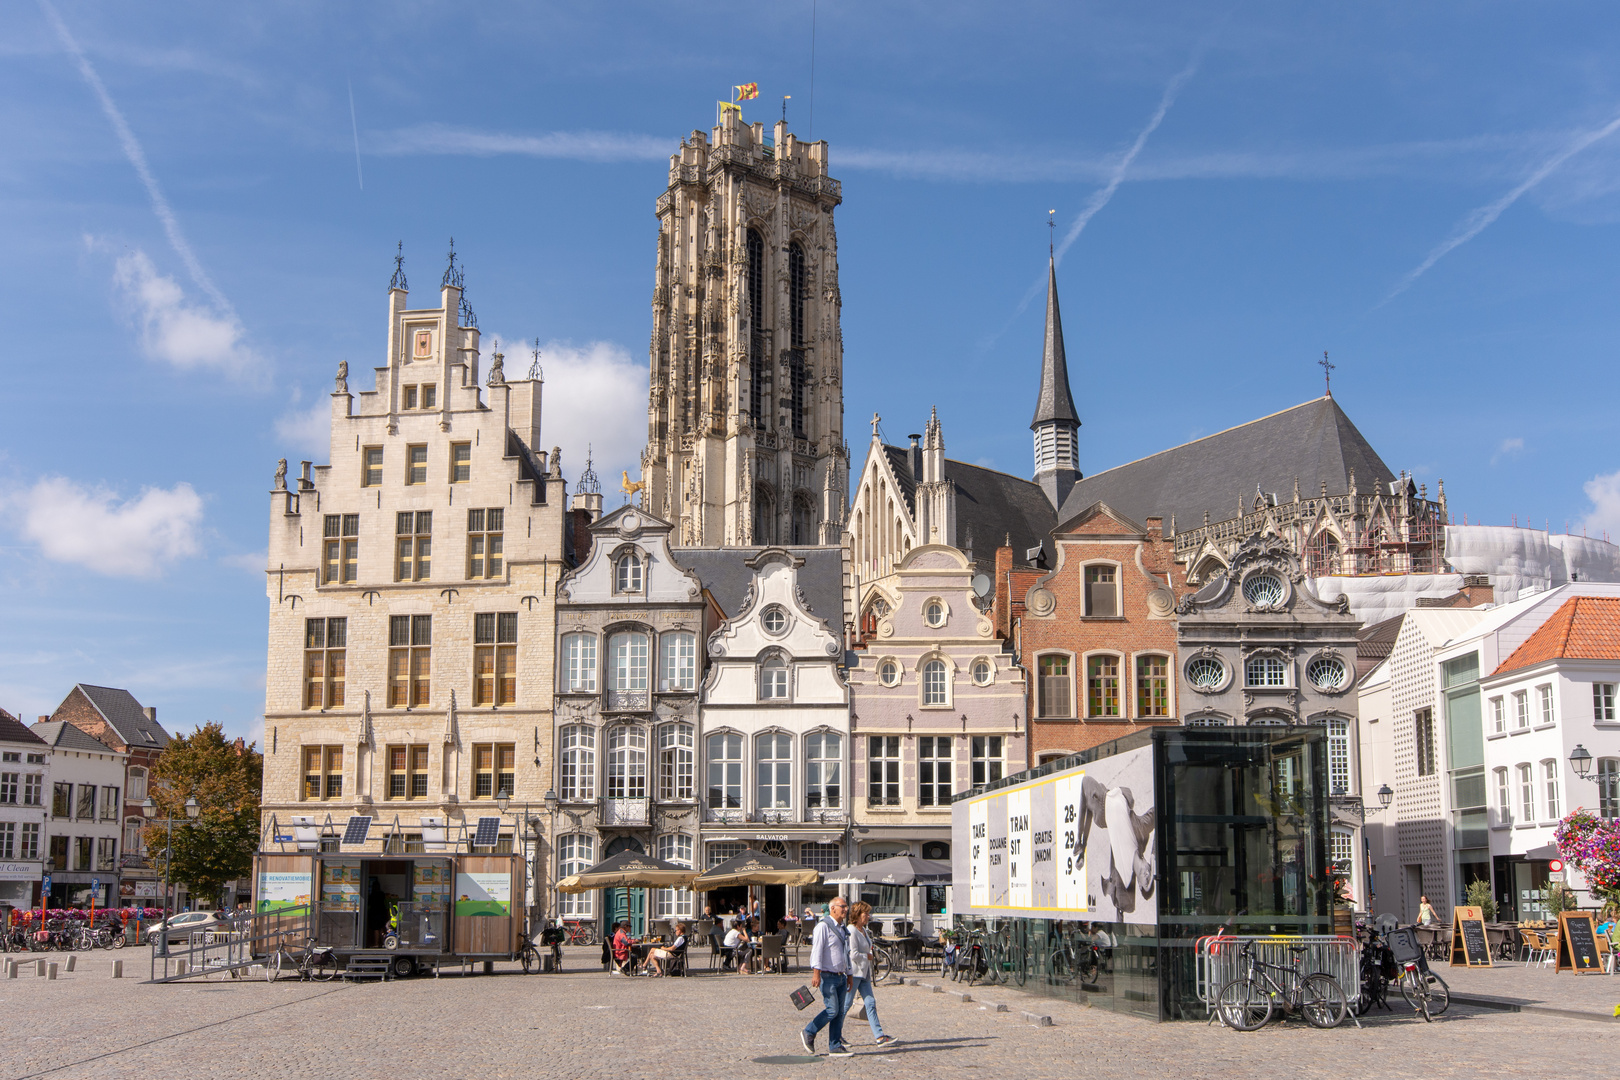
[{"left": 849, "top": 544, "right": 1029, "bottom": 934}]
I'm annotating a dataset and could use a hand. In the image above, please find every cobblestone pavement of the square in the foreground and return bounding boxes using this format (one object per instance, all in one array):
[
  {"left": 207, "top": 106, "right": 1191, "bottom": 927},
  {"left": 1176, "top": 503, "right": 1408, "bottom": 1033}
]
[{"left": 0, "top": 949, "right": 1620, "bottom": 1080}]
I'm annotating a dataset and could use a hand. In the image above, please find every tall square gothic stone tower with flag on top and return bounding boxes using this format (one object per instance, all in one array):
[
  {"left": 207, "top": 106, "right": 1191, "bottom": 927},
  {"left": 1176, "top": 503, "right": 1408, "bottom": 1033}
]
[{"left": 642, "top": 110, "right": 849, "bottom": 547}]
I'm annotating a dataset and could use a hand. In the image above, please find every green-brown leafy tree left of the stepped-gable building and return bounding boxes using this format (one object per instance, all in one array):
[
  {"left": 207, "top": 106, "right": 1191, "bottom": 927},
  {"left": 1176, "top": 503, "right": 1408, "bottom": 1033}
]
[{"left": 144, "top": 722, "right": 264, "bottom": 902}]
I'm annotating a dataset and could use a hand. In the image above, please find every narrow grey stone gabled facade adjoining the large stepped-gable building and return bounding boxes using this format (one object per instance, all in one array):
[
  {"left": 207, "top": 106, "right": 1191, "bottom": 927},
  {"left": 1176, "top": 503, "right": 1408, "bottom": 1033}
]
[{"left": 554, "top": 507, "right": 705, "bottom": 933}]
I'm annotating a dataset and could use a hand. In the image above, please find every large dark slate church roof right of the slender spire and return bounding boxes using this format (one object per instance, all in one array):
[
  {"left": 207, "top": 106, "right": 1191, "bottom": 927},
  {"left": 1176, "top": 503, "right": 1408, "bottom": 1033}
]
[{"left": 1058, "top": 397, "right": 1395, "bottom": 531}]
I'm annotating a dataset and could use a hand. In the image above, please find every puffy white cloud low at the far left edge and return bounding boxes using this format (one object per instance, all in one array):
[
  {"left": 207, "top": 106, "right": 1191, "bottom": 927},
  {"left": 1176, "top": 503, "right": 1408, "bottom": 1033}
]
[{"left": 10, "top": 476, "right": 203, "bottom": 578}]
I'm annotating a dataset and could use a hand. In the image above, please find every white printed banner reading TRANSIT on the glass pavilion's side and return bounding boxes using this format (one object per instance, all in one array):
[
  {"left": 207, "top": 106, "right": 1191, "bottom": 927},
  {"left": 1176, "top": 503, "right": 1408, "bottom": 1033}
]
[{"left": 951, "top": 746, "right": 1158, "bottom": 925}]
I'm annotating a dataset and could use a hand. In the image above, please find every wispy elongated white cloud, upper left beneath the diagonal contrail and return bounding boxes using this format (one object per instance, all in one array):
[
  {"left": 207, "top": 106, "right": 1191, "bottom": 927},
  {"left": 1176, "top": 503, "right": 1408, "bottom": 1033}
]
[{"left": 110, "top": 249, "right": 264, "bottom": 379}]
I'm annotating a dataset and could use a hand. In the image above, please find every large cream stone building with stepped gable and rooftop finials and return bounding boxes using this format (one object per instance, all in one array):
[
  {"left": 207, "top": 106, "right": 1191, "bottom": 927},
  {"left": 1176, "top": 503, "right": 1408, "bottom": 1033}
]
[{"left": 264, "top": 256, "right": 569, "bottom": 919}]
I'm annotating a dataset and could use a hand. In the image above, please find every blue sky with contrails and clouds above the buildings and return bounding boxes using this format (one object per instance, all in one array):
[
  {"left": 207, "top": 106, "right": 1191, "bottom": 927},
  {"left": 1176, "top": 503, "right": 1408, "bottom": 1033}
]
[{"left": 0, "top": 0, "right": 1620, "bottom": 737}]
